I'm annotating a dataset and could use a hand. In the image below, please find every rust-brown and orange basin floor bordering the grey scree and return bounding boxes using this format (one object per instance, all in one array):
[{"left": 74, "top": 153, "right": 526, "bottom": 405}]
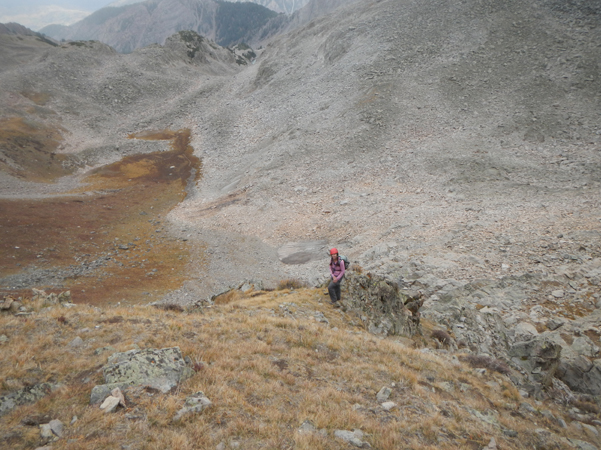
[{"left": 0, "top": 130, "right": 202, "bottom": 304}]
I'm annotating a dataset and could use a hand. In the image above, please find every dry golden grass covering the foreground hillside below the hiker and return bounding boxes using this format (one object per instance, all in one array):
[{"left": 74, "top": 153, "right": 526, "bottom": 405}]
[{"left": 0, "top": 289, "right": 583, "bottom": 450}]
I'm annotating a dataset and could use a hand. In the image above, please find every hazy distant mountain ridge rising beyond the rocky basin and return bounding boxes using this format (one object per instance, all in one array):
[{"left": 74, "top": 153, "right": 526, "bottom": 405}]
[{"left": 40, "top": 0, "right": 356, "bottom": 53}]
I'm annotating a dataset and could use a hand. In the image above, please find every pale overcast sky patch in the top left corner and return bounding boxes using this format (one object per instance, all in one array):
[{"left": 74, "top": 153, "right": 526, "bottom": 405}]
[{"left": 0, "top": 0, "right": 124, "bottom": 31}]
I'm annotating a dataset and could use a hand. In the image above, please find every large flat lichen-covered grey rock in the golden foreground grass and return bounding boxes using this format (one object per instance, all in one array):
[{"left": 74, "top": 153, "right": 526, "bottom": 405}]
[{"left": 90, "top": 347, "right": 194, "bottom": 404}]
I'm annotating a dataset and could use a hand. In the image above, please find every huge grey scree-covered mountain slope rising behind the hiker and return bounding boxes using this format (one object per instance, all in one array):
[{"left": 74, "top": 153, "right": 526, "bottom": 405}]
[{"left": 1, "top": 0, "right": 601, "bottom": 296}]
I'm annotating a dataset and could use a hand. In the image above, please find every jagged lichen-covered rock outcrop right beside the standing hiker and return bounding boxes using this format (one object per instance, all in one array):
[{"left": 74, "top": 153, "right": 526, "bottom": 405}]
[{"left": 342, "top": 272, "right": 419, "bottom": 336}]
